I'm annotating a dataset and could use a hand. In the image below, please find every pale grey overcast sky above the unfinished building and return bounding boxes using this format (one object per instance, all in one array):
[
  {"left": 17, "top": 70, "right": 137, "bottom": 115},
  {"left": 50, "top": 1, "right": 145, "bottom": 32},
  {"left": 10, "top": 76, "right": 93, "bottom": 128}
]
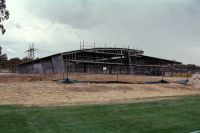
[{"left": 0, "top": 0, "right": 200, "bottom": 65}]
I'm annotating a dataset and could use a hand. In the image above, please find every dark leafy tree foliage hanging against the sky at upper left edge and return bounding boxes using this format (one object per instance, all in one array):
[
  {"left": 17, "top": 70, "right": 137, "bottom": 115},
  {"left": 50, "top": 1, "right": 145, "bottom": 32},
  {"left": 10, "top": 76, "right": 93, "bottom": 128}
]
[{"left": 0, "top": 0, "right": 10, "bottom": 34}]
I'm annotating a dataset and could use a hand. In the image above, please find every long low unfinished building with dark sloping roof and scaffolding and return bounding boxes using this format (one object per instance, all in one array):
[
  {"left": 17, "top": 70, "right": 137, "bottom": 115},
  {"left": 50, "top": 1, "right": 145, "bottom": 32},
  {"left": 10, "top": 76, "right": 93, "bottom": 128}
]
[{"left": 17, "top": 48, "right": 181, "bottom": 75}]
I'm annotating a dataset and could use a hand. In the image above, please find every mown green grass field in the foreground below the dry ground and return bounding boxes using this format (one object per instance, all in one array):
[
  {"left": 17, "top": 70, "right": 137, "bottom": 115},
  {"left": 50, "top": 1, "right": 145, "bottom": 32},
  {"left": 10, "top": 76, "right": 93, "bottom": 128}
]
[{"left": 0, "top": 96, "right": 200, "bottom": 133}]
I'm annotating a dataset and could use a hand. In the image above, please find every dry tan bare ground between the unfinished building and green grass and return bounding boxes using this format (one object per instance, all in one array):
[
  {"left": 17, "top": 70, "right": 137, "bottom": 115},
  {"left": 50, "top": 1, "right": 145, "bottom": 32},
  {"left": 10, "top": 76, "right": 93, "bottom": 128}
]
[{"left": 0, "top": 73, "right": 200, "bottom": 106}]
